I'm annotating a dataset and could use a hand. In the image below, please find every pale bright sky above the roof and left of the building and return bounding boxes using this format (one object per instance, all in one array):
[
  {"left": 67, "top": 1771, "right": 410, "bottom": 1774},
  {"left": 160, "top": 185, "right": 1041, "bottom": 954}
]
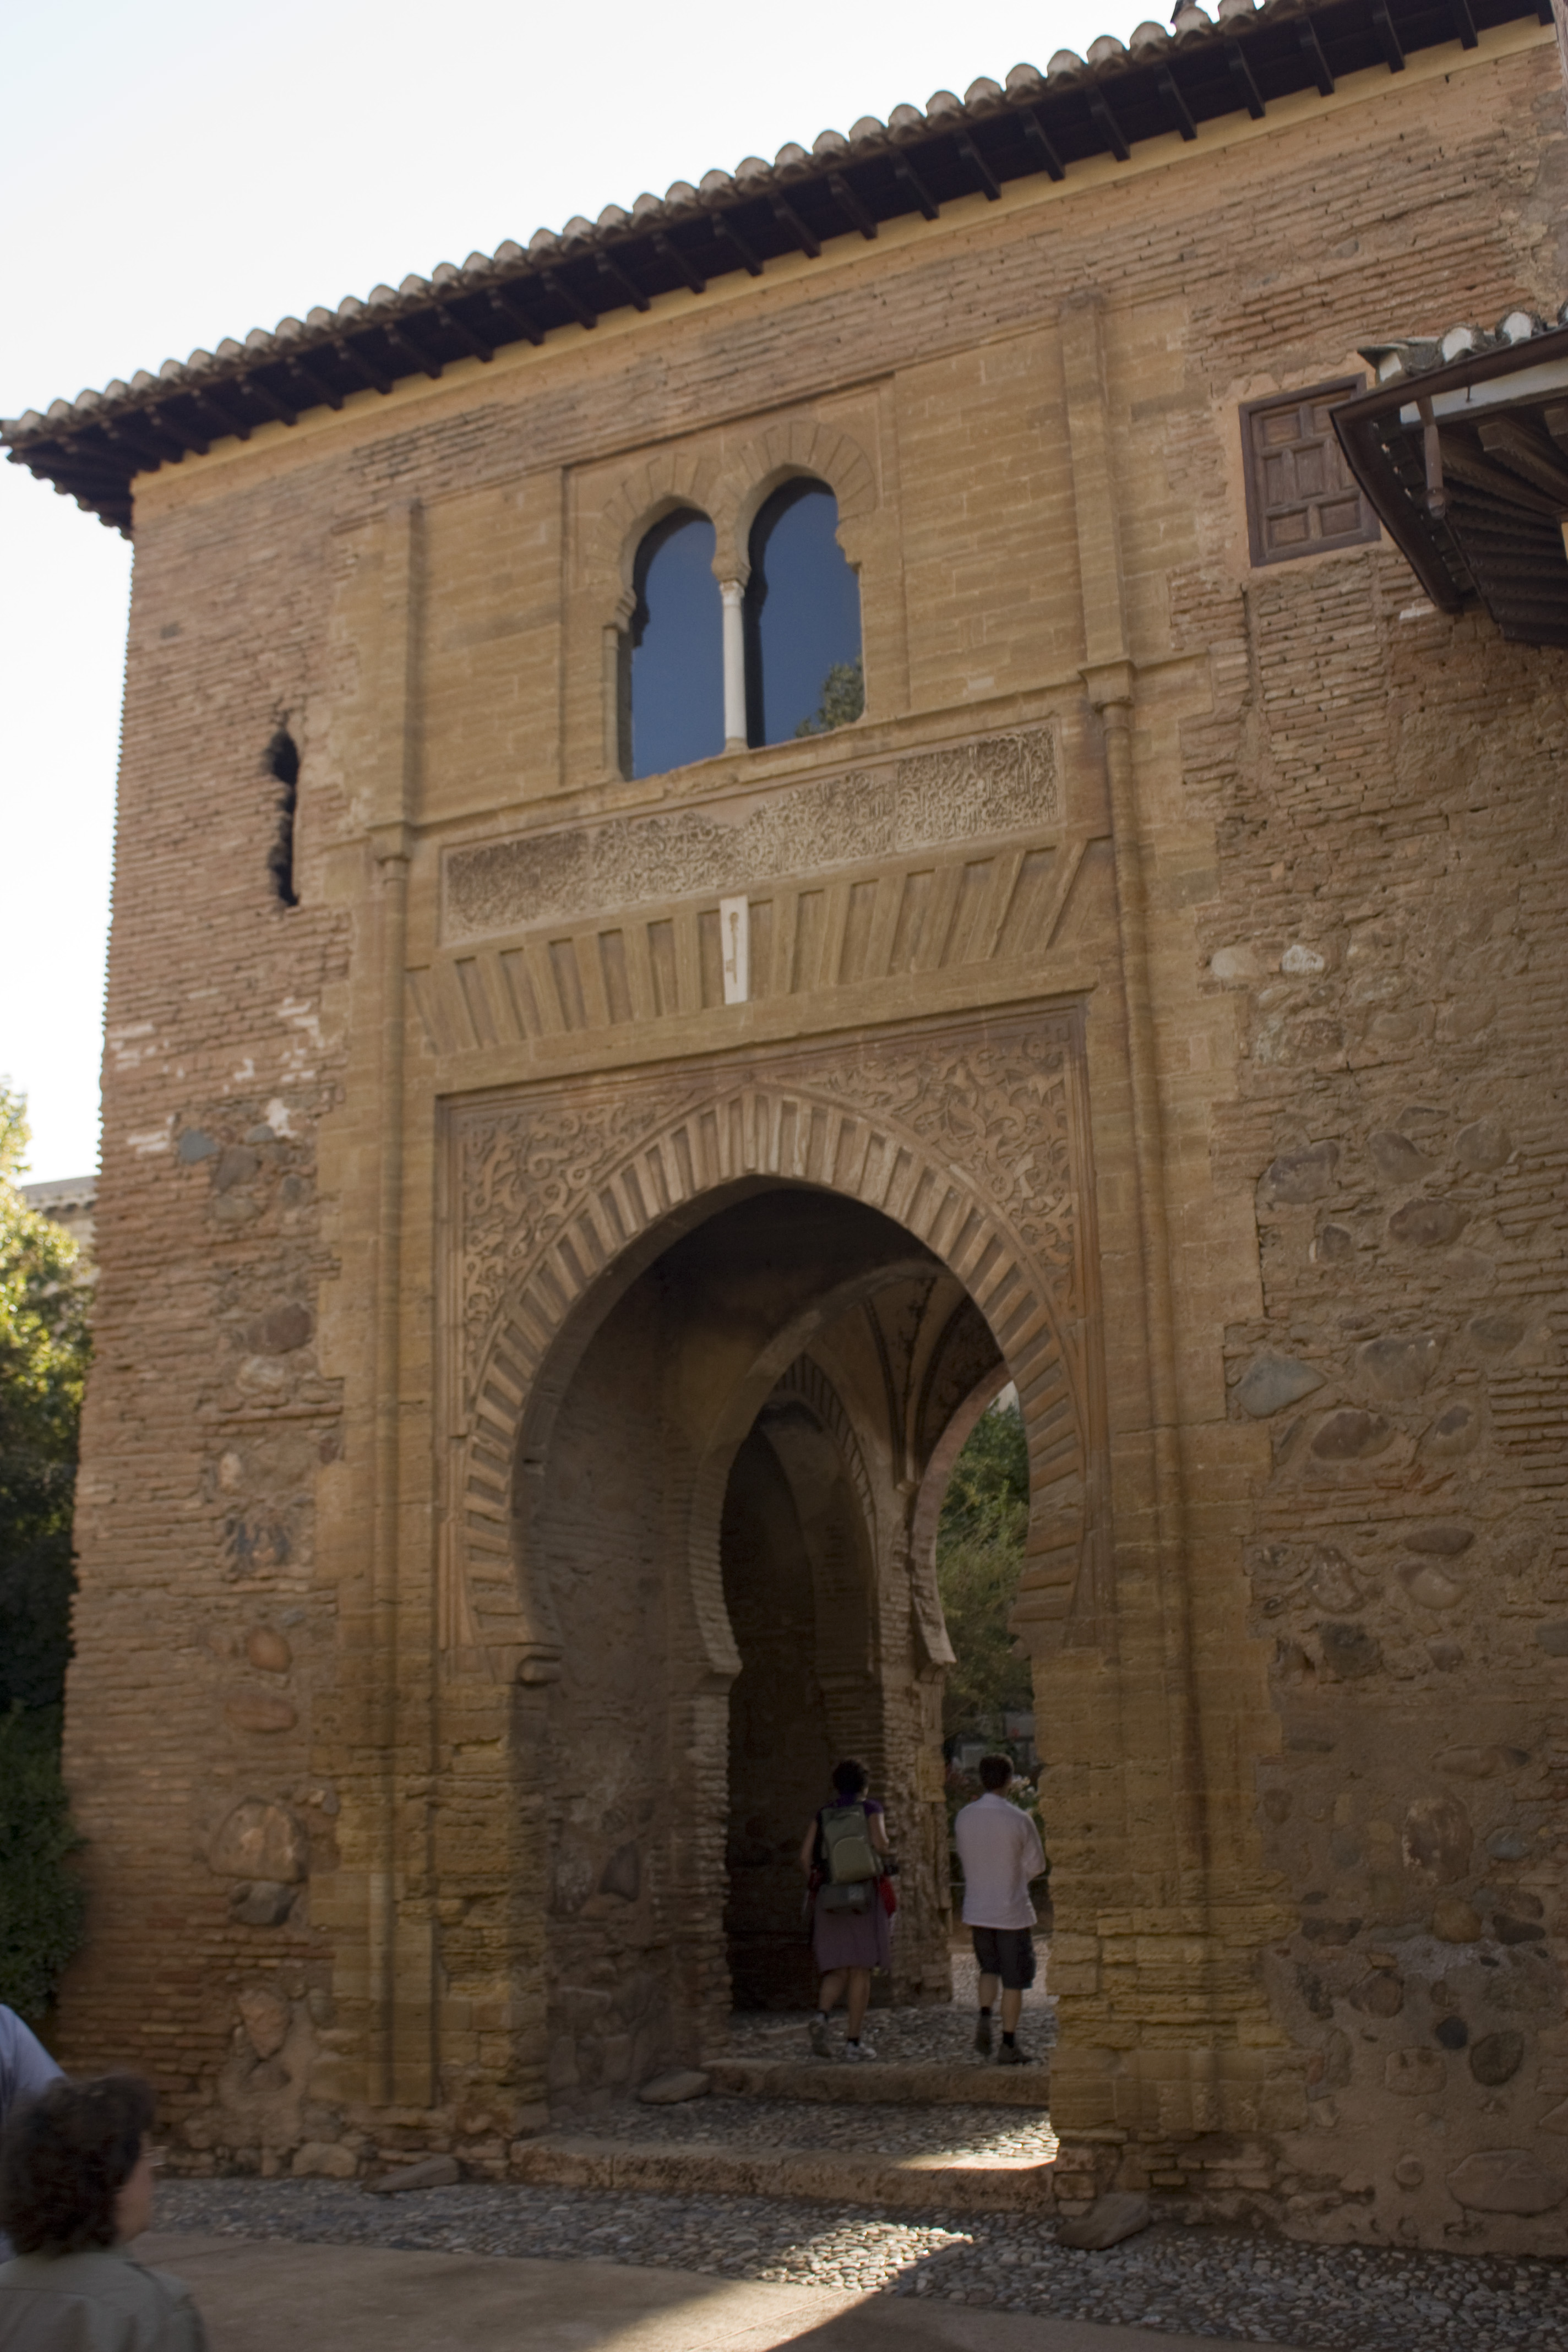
[{"left": 0, "top": 0, "right": 1109, "bottom": 1178}]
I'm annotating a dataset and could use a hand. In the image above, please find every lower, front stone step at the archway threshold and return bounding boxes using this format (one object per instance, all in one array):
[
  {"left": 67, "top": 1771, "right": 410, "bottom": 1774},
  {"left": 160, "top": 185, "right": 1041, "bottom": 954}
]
[{"left": 510, "top": 2133, "right": 1055, "bottom": 2213}]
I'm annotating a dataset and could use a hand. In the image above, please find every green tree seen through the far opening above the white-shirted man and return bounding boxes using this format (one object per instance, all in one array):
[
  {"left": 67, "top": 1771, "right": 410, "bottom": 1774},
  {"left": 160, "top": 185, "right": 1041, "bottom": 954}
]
[{"left": 935, "top": 1402, "right": 1035, "bottom": 1738}]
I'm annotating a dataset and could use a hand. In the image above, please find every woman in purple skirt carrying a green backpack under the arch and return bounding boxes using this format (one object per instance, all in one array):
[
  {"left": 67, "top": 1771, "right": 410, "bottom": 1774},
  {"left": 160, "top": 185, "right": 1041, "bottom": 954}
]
[{"left": 799, "top": 1757, "right": 894, "bottom": 2060}]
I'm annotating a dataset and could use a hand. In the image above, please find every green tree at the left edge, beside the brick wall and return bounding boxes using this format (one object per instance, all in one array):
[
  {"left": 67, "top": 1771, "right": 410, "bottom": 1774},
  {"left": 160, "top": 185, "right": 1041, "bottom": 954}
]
[{"left": 0, "top": 1084, "right": 89, "bottom": 2016}]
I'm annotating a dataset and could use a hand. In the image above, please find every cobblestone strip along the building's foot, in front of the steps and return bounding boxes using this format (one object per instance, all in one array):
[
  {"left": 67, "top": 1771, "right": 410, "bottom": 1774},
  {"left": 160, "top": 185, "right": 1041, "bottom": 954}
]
[{"left": 157, "top": 2180, "right": 1568, "bottom": 2352}]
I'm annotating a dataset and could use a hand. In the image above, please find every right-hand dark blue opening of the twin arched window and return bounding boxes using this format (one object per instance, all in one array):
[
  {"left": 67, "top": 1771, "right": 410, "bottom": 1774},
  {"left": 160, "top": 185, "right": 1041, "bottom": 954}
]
[{"left": 745, "top": 480, "right": 865, "bottom": 743}]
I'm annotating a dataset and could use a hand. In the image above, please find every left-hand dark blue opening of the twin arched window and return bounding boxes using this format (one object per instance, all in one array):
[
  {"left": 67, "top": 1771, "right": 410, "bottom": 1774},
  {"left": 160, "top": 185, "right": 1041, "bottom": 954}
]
[{"left": 623, "top": 505, "right": 724, "bottom": 776}]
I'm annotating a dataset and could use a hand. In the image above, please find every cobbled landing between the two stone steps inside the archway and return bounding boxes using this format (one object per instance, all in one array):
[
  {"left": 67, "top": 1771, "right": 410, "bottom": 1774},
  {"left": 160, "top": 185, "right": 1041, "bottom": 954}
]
[{"left": 567, "top": 2107, "right": 1055, "bottom": 2164}]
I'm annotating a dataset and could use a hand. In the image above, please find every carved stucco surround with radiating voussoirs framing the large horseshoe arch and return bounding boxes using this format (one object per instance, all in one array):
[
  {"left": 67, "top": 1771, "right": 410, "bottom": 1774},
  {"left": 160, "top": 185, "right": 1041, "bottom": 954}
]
[{"left": 442, "top": 1006, "right": 1107, "bottom": 1679}]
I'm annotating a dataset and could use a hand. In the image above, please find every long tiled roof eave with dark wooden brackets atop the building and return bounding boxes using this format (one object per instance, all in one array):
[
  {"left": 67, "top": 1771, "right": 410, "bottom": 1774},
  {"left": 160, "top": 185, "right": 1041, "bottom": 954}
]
[{"left": 0, "top": 0, "right": 1551, "bottom": 534}]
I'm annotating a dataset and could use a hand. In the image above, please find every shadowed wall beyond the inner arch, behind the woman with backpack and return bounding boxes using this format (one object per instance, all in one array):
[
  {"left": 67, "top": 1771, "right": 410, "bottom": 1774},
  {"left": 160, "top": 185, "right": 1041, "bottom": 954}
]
[{"left": 722, "top": 1317, "right": 987, "bottom": 2006}]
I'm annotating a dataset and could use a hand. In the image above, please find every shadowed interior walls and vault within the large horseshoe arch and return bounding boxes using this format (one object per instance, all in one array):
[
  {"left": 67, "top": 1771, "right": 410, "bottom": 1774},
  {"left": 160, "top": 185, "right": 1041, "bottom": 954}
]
[{"left": 515, "top": 1185, "right": 999, "bottom": 2105}]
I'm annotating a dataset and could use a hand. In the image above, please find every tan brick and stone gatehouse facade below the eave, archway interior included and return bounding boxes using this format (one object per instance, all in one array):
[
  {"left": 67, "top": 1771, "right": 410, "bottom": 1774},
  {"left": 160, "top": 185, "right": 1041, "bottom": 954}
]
[{"left": 12, "top": 0, "right": 1568, "bottom": 2253}]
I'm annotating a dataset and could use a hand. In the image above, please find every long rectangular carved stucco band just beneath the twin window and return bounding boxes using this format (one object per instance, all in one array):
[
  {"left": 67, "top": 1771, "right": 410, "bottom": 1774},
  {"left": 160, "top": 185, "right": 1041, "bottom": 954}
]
[{"left": 442, "top": 727, "right": 1060, "bottom": 941}]
